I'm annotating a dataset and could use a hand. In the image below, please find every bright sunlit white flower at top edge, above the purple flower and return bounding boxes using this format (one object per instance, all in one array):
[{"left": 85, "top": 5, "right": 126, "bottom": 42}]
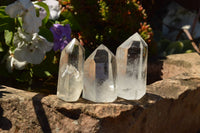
[{"left": 43, "top": 0, "right": 61, "bottom": 20}]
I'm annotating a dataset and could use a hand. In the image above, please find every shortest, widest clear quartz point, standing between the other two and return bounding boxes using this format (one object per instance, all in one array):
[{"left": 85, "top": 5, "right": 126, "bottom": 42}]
[{"left": 83, "top": 45, "right": 117, "bottom": 102}]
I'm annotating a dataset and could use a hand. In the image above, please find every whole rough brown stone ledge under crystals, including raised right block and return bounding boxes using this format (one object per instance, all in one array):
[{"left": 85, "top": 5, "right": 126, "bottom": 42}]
[{"left": 0, "top": 53, "right": 200, "bottom": 133}]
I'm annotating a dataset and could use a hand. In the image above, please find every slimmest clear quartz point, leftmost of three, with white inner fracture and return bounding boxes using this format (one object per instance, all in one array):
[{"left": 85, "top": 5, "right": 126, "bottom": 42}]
[{"left": 57, "top": 38, "right": 85, "bottom": 101}]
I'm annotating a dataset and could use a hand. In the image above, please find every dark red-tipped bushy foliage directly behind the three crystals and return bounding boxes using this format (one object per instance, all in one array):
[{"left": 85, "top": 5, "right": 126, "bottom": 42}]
[{"left": 60, "top": 0, "right": 153, "bottom": 53}]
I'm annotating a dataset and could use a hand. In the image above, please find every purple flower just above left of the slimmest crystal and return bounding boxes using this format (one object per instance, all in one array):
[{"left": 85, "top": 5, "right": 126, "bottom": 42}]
[{"left": 50, "top": 24, "right": 71, "bottom": 51}]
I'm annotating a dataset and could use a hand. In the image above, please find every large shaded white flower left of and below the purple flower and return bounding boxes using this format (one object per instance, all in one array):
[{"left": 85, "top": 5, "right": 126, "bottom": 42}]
[{"left": 14, "top": 30, "right": 53, "bottom": 64}]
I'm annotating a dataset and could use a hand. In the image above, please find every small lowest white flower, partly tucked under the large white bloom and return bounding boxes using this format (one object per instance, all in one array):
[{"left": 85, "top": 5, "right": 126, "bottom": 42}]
[{"left": 6, "top": 52, "right": 27, "bottom": 72}]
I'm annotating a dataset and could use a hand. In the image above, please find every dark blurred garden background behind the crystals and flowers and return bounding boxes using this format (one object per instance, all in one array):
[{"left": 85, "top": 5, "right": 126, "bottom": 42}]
[{"left": 0, "top": 0, "right": 200, "bottom": 93}]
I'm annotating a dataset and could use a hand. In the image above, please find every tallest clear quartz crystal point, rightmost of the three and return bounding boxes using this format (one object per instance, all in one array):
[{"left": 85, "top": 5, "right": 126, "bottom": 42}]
[{"left": 116, "top": 33, "right": 148, "bottom": 100}]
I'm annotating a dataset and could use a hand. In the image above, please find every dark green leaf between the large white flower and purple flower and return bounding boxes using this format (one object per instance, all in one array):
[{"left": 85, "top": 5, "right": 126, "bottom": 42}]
[{"left": 39, "top": 27, "right": 53, "bottom": 42}]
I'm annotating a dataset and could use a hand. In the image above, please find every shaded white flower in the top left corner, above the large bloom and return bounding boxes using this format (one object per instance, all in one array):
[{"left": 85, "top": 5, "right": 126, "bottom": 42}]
[{"left": 5, "top": 0, "right": 42, "bottom": 34}]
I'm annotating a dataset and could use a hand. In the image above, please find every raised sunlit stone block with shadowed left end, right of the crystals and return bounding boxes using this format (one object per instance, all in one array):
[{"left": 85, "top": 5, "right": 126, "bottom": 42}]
[{"left": 147, "top": 53, "right": 200, "bottom": 84}]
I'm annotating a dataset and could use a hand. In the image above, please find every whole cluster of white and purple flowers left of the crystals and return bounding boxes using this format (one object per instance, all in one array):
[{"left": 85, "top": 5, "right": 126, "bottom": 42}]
[{"left": 2, "top": 0, "right": 71, "bottom": 72}]
